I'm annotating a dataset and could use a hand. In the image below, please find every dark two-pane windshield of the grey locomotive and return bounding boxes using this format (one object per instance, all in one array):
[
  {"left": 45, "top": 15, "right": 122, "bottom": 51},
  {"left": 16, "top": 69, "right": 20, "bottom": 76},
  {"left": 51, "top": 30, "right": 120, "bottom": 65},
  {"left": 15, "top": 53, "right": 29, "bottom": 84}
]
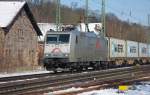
[{"left": 46, "top": 34, "right": 70, "bottom": 44}]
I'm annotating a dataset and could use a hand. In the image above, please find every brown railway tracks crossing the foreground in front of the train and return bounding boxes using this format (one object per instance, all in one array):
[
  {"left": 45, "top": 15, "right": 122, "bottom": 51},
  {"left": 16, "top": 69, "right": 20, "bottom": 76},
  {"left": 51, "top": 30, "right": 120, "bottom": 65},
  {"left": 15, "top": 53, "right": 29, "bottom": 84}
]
[{"left": 0, "top": 65, "right": 150, "bottom": 95}]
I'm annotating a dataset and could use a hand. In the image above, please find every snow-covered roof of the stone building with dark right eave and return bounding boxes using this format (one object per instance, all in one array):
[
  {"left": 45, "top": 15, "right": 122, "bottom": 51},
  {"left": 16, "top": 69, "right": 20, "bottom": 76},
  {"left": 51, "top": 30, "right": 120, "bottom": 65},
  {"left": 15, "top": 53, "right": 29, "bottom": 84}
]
[{"left": 0, "top": 1, "right": 42, "bottom": 35}]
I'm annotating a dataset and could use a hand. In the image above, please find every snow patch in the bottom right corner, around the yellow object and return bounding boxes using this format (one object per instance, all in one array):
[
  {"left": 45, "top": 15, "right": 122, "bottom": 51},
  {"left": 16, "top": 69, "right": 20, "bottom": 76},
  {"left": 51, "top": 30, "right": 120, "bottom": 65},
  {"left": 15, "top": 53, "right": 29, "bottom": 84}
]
[{"left": 78, "top": 82, "right": 150, "bottom": 95}]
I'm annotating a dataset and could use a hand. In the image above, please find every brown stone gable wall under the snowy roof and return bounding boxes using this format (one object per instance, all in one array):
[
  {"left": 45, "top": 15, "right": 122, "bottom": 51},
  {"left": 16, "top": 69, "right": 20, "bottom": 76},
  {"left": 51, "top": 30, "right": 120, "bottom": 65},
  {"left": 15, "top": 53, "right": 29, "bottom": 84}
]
[{"left": 4, "top": 10, "right": 38, "bottom": 69}]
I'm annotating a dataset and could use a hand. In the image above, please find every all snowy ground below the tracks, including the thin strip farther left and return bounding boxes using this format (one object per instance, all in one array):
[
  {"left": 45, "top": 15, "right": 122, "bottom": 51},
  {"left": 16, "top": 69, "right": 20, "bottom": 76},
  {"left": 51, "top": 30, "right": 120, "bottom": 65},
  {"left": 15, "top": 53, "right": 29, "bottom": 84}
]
[{"left": 44, "top": 82, "right": 150, "bottom": 95}]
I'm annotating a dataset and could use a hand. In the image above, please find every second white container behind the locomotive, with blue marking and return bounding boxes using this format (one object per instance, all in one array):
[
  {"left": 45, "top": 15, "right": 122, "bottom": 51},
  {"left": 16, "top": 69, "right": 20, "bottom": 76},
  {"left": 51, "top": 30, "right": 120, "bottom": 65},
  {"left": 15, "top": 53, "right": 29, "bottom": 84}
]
[{"left": 126, "top": 41, "right": 138, "bottom": 58}]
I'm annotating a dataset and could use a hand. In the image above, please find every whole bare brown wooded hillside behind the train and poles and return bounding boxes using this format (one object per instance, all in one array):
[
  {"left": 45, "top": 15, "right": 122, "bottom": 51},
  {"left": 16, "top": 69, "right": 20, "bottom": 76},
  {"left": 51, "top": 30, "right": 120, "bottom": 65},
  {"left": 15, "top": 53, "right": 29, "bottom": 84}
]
[{"left": 0, "top": 0, "right": 150, "bottom": 43}]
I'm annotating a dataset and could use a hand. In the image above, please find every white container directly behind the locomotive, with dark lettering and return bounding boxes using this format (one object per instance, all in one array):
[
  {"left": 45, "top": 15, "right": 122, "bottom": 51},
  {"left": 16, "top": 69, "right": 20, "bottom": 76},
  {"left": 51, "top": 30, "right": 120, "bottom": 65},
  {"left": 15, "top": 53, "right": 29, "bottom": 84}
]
[{"left": 109, "top": 38, "right": 126, "bottom": 58}]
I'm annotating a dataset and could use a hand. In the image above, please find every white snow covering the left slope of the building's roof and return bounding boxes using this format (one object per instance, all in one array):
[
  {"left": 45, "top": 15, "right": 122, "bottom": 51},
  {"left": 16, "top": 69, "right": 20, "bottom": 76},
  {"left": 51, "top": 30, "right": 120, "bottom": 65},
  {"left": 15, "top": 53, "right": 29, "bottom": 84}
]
[{"left": 0, "top": 1, "right": 25, "bottom": 27}]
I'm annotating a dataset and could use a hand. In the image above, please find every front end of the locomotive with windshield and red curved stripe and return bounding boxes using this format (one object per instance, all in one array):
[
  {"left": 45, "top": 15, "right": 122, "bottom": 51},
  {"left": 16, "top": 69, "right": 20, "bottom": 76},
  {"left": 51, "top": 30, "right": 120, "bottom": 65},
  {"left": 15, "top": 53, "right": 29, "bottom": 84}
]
[{"left": 44, "top": 32, "right": 70, "bottom": 69}]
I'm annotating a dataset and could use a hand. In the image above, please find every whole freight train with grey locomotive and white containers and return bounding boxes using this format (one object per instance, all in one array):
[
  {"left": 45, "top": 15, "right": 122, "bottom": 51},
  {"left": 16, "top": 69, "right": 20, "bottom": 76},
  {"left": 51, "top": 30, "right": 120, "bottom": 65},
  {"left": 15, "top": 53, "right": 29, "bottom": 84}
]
[{"left": 43, "top": 24, "right": 150, "bottom": 71}]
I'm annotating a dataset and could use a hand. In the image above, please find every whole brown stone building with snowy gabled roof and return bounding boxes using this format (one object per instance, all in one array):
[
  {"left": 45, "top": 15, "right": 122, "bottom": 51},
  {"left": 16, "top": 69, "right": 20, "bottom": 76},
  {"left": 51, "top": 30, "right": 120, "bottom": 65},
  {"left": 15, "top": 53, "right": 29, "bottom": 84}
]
[{"left": 0, "top": 1, "right": 42, "bottom": 71}]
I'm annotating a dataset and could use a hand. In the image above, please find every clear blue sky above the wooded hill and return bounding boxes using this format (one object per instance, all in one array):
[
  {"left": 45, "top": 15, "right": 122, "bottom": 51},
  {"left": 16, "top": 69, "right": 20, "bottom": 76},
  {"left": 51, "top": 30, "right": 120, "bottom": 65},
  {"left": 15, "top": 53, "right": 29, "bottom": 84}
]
[{"left": 61, "top": 0, "right": 150, "bottom": 25}]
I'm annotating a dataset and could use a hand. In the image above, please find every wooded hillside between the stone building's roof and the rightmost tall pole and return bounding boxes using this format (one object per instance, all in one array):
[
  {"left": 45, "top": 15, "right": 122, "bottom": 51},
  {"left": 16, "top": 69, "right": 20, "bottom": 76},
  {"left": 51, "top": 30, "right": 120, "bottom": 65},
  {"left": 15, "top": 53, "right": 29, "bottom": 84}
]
[{"left": 28, "top": 0, "right": 99, "bottom": 24}]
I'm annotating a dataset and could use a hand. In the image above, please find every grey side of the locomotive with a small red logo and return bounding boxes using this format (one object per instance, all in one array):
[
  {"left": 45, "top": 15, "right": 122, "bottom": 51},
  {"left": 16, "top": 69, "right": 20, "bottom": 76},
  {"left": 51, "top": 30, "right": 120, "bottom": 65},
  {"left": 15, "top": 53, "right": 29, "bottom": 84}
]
[{"left": 72, "top": 33, "right": 108, "bottom": 62}]
